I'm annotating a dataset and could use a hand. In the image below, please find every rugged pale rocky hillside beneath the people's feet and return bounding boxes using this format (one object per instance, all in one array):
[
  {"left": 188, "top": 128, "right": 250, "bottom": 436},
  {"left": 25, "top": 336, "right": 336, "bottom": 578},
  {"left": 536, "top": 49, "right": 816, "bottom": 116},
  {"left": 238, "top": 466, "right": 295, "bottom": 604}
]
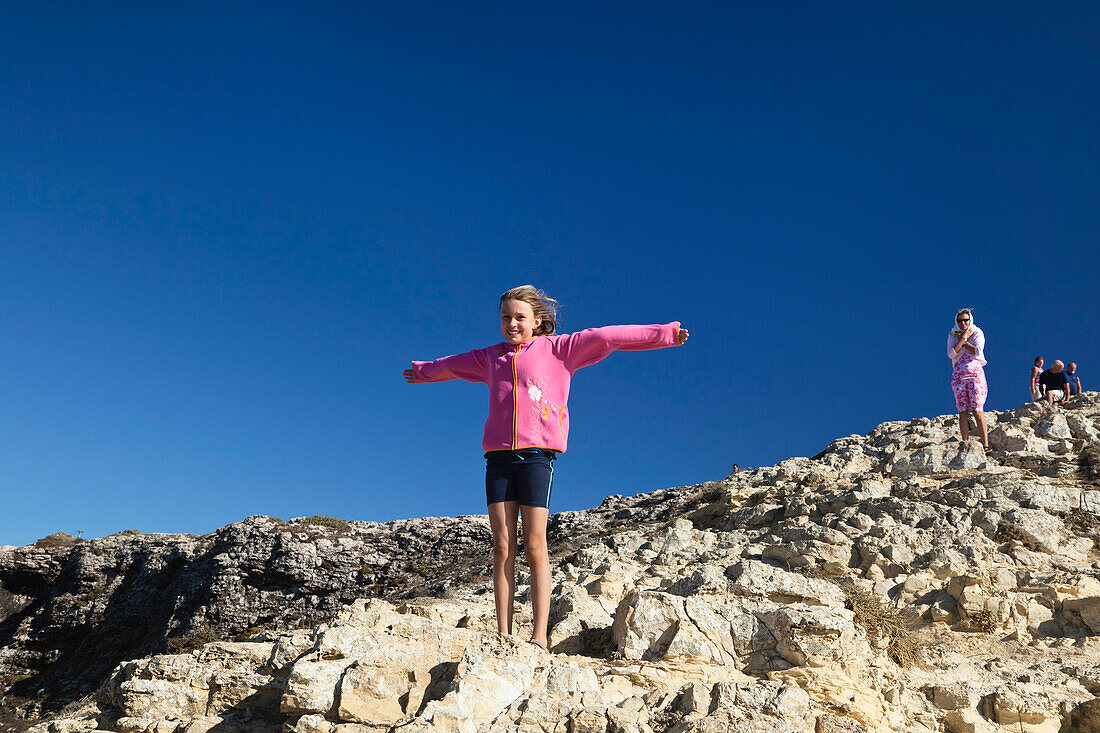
[{"left": 0, "top": 393, "right": 1100, "bottom": 733}]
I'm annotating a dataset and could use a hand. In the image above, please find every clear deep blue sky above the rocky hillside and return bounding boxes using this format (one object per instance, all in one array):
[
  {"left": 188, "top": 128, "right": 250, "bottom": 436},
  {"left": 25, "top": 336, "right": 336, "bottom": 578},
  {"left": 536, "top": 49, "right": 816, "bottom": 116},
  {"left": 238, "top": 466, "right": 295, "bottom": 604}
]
[{"left": 0, "top": 1, "right": 1100, "bottom": 545}]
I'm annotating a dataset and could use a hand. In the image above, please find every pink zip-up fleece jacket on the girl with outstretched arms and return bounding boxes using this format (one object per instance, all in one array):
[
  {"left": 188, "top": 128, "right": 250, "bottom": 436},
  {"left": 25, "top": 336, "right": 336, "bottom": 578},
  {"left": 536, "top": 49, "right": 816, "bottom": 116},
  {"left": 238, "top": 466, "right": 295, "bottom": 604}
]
[{"left": 413, "top": 321, "right": 680, "bottom": 452}]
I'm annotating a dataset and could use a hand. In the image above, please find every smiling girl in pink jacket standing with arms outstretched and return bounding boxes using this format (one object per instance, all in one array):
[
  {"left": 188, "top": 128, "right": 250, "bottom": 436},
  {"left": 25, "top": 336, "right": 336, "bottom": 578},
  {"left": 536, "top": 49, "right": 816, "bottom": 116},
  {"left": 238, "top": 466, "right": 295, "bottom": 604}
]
[{"left": 403, "top": 285, "right": 688, "bottom": 649}]
